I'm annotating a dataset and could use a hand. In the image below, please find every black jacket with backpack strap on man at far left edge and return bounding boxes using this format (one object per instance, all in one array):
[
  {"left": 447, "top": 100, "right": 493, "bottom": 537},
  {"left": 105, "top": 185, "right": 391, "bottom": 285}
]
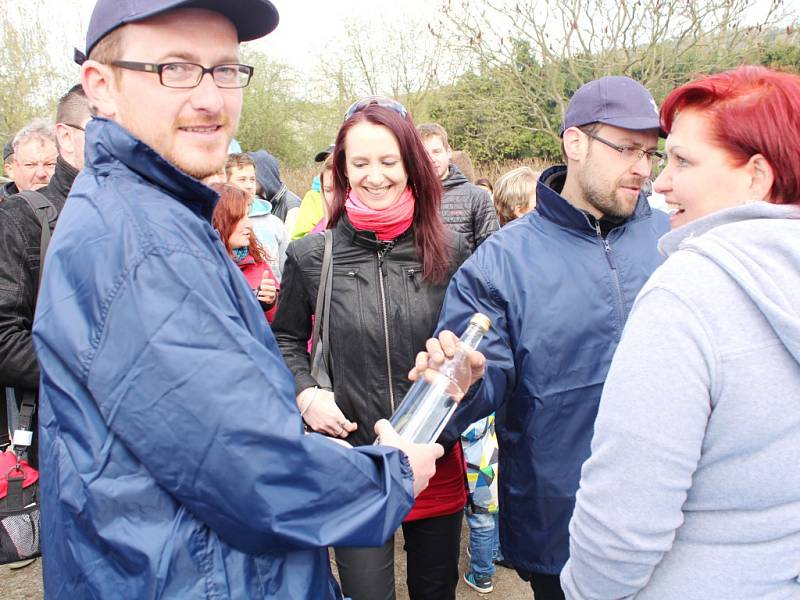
[{"left": 0, "top": 157, "right": 78, "bottom": 389}]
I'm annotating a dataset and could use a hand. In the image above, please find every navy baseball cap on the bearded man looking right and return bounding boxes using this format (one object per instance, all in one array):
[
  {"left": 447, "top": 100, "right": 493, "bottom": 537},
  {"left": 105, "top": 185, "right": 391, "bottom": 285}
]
[{"left": 558, "top": 76, "right": 663, "bottom": 135}]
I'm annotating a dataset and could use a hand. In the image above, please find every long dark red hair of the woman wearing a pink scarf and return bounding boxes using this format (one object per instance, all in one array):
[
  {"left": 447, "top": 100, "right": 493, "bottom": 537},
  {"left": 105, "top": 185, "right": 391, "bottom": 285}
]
[{"left": 328, "top": 104, "right": 450, "bottom": 282}]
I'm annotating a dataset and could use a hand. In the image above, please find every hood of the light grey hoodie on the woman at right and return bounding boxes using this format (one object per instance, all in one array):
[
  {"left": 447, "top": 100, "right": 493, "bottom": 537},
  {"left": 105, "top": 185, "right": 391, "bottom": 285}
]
[{"left": 659, "top": 202, "right": 800, "bottom": 362}]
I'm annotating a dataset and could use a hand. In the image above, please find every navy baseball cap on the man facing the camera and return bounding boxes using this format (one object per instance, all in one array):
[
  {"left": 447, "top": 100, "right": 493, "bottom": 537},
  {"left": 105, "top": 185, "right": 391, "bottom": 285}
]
[{"left": 75, "top": 0, "right": 278, "bottom": 64}]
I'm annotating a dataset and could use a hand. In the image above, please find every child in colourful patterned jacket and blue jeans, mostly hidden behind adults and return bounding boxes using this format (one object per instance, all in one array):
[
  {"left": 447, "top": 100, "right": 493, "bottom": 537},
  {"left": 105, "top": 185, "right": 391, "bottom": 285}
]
[{"left": 461, "top": 414, "right": 510, "bottom": 594}]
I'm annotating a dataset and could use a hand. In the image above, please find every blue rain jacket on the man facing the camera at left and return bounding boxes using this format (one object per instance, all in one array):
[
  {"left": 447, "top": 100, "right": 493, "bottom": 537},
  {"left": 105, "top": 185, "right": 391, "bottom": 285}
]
[{"left": 33, "top": 119, "right": 413, "bottom": 600}]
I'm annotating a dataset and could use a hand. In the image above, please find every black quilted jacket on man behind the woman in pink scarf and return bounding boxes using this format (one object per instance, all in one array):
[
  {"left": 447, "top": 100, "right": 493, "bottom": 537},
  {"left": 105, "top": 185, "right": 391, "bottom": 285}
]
[{"left": 441, "top": 164, "right": 500, "bottom": 252}]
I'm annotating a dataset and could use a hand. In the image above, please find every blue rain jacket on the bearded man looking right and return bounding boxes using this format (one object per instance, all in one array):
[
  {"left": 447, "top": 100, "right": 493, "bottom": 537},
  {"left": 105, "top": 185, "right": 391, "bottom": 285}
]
[{"left": 437, "top": 167, "right": 669, "bottom": 574}]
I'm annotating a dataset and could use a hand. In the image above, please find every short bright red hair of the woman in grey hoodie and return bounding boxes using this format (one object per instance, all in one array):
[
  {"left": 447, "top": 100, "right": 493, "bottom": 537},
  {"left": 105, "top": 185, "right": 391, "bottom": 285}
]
[{"left": 661, "top": 66, "right": 800, "bottom": 204}]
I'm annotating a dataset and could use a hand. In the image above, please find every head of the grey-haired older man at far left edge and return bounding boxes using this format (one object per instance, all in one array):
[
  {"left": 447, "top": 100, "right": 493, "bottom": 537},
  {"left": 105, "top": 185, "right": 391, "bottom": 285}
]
[{"left": 0, "top": 119, "right": 58, "bottom": 199}]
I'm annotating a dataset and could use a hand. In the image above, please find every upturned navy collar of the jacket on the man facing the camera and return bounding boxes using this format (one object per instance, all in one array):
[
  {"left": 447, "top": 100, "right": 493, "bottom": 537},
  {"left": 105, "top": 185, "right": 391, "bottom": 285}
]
[{"left": 86, "top": 117, "right": 219, "bottom": 223}]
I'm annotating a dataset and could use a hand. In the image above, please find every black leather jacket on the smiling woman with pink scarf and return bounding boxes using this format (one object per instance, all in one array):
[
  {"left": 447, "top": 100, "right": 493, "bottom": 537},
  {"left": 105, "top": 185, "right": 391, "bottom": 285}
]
[{"left": 272, "top": 216, "right": 468, "bottom": 445}]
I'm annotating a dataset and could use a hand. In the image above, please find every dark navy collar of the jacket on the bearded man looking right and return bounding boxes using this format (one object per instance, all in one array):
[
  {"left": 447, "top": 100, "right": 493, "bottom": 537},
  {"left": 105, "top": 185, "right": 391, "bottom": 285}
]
[{"left": 536, "top": 165, "right": 652, "bottom": 234}]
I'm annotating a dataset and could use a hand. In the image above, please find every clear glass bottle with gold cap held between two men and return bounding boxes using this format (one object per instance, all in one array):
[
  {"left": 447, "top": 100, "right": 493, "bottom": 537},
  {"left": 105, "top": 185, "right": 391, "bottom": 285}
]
[{"left": 390, "top": 313, "right": 492, "bottom": 444}]
